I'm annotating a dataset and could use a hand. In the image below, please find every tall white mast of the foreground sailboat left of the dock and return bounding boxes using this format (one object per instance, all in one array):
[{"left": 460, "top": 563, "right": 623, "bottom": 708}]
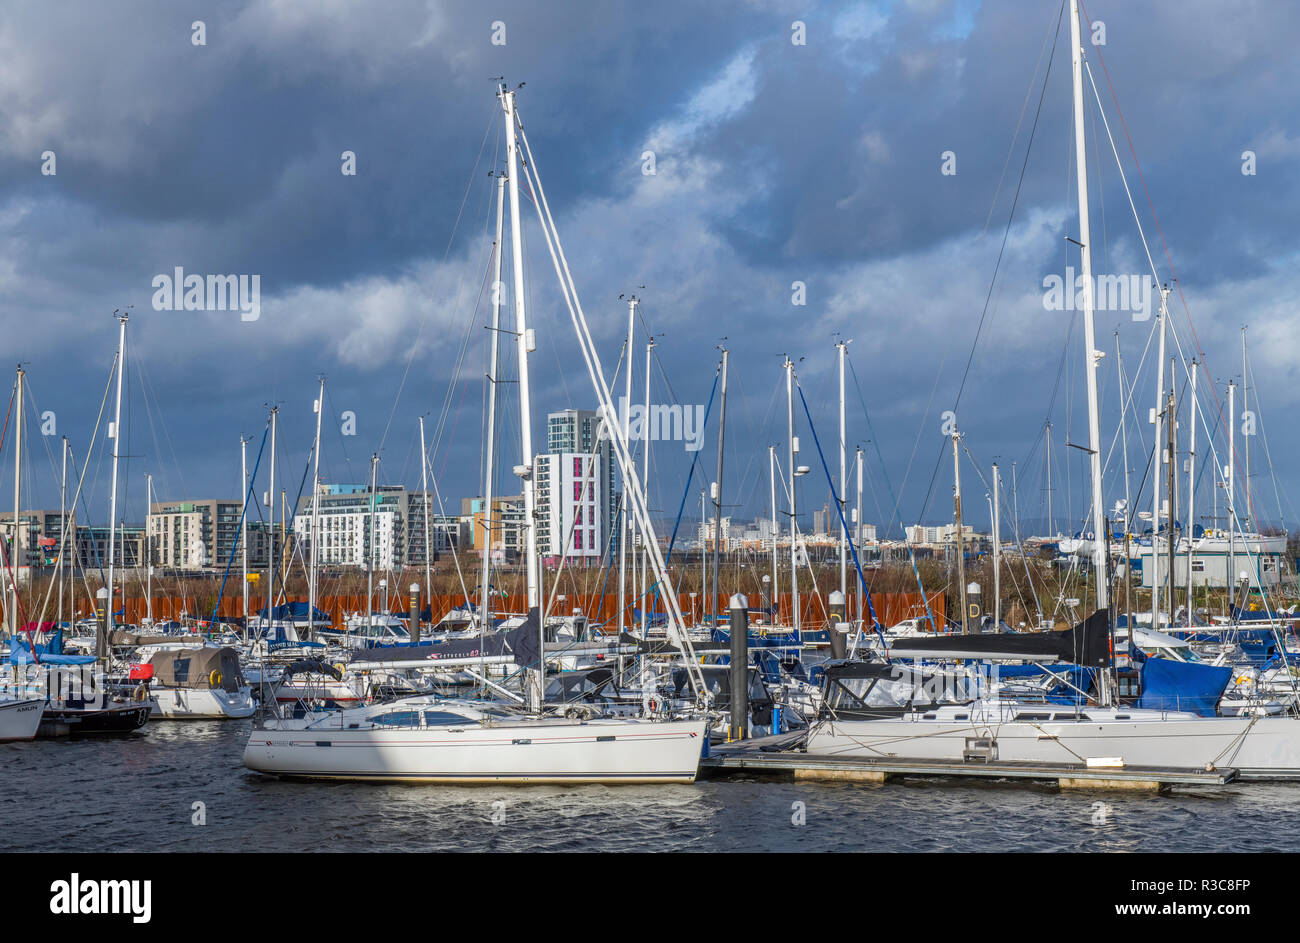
[{"left": 501, "top": 85, "right": 546, "bottom": 710}]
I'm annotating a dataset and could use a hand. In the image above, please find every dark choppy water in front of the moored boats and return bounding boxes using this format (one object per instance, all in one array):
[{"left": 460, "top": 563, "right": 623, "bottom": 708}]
[{"left": 0, "top": 721, "right": 1300, "bottom": 852}]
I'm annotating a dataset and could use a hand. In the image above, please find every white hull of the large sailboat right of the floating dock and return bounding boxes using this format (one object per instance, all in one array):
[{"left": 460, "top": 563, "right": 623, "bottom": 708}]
[{"left": 807, "top": 708, "right": 1300, "bottom": 779}]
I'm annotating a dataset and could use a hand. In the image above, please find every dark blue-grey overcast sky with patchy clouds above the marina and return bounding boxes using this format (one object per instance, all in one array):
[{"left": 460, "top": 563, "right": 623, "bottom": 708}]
[{"left": 0, "top": 0, "right": 1300, "bottom": 529}]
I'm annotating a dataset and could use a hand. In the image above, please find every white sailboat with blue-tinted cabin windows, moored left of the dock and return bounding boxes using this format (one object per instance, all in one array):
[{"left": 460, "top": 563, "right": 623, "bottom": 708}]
[{"left": 243, "top": 85, "right": 709, "bottom": 783}]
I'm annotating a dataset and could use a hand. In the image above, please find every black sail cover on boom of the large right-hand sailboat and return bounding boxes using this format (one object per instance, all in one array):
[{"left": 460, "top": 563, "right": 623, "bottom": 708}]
[{"left": 889, "top": 609, "right": 1110, "bottom": 667}]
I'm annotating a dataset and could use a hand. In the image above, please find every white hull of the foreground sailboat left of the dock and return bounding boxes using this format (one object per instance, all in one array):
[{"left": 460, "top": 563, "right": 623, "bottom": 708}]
[{"left": 243, "top": 718, "right": 706, "bottom": 783}]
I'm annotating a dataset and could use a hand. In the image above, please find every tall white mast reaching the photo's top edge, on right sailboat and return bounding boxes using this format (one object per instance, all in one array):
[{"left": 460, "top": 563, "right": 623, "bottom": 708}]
[{"left": 1070, "top": 0, "right": 1110, "bottom": 619}]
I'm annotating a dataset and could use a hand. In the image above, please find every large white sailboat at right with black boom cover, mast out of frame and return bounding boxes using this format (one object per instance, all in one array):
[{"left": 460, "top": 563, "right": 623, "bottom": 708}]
[{"left": 806, "top": 0, "right": 1300, "bottom": 779}]
